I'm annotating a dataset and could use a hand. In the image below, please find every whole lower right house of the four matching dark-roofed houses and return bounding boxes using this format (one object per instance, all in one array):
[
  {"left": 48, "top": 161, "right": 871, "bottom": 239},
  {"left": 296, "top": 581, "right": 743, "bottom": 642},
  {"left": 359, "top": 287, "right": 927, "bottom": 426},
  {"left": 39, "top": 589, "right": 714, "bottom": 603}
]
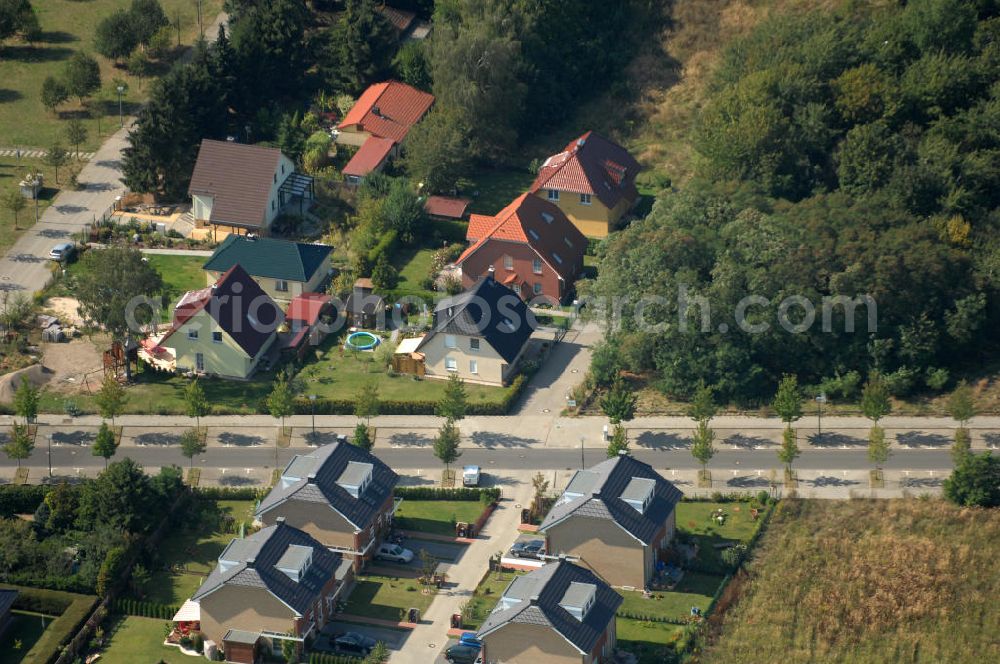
[{"left": 476, "top": 560, "right": 622, "bottom": 664}]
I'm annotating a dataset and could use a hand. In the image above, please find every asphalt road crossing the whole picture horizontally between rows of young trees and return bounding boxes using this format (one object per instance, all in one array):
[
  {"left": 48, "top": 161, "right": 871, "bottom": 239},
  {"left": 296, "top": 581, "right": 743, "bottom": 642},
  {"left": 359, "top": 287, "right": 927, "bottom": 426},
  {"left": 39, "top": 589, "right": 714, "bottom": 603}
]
[{"left": 13, "top": 444, "right": 952, "bottom": 475}]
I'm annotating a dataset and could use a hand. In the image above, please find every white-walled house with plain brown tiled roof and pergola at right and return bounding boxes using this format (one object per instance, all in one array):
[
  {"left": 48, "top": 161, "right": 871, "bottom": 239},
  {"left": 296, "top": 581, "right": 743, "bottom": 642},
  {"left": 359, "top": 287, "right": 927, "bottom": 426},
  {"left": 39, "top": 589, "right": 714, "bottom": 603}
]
[{"left": 188, "top": 138, "right": 314, "bottom": 235}]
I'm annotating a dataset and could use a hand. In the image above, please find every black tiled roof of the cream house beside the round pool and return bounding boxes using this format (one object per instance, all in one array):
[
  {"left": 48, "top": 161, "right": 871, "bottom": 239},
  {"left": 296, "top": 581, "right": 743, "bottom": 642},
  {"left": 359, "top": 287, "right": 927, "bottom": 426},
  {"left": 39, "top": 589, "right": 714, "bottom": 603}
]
[{"left": 418, "top": 277, "right": 534, "bottom": 362}]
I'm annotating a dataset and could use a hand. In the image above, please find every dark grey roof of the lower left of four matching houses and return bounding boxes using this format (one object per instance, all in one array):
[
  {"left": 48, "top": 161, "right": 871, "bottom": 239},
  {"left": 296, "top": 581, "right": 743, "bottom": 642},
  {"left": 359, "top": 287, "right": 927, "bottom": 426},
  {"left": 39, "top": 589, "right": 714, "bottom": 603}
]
[{"left": 191, "top": 523, "right": 341, "bottom": 615}]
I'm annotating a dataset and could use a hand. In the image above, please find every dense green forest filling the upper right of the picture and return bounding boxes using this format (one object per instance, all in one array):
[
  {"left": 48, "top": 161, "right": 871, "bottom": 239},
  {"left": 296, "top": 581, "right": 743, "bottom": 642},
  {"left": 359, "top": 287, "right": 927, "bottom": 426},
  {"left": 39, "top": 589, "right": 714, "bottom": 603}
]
[{"left": 588, "top": 0, "right": 1000, "bottom": 404}]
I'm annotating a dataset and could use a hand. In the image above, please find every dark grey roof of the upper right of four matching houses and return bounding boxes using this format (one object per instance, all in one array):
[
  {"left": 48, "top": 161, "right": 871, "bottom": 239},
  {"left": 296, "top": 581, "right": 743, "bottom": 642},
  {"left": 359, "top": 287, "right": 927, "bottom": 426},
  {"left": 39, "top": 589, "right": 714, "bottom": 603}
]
[{"left": 540, "top": 455, "right": 683, "bottom": 544}]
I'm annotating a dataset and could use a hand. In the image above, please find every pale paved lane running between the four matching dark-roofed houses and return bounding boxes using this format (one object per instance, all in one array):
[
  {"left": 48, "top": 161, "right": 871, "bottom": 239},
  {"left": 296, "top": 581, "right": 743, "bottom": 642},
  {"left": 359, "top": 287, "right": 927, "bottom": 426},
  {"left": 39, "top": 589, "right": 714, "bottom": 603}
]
[{"left": 390, "top": 481, "right": 532, "bottom": 664}]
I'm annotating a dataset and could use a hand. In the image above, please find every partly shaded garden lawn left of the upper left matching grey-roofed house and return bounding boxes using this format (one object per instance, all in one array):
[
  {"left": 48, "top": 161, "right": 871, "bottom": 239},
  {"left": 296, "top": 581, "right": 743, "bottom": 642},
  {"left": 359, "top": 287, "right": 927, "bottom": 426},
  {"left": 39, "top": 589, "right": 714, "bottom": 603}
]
[{"left": 143, "top": 500, "right": 254, "bottom": 606}]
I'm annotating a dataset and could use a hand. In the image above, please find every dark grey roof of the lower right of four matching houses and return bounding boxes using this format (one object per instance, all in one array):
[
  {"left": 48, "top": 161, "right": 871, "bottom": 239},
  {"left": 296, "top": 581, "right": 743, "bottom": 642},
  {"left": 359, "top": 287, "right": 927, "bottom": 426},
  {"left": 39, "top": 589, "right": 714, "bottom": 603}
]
[{"left": 477, "top": 560, "right": 622, "bottom": 652}]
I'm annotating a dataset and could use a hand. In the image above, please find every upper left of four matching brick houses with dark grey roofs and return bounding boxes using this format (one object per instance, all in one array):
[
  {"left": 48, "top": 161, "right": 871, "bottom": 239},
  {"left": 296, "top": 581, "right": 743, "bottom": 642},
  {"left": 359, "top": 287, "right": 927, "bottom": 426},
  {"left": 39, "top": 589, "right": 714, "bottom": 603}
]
[{"left": 256, "top": 442, "right": 399, "bottom": 569}]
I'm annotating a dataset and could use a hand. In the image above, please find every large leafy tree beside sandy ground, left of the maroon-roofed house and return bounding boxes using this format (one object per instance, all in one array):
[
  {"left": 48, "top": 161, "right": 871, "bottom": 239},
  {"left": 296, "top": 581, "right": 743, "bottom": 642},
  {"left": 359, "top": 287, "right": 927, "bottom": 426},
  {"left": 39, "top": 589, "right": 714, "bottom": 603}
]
[{"left": 76, "top": 247, "right": 163, "bottom": 380}]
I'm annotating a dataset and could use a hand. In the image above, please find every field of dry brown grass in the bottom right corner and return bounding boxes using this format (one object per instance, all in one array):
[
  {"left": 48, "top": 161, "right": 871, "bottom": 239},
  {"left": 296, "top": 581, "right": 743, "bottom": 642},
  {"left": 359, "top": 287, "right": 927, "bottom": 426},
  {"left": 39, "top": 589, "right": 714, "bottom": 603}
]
[{"left": 699, "top": 500, "right": 1000, "bottom": 664}]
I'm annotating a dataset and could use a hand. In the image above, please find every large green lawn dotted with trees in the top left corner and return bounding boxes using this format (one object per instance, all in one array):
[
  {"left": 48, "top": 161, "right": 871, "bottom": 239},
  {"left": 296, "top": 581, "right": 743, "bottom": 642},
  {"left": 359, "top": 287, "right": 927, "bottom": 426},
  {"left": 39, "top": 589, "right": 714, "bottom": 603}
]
[{"left": 0, "top": 0, "right": 222, "bottom": 150}]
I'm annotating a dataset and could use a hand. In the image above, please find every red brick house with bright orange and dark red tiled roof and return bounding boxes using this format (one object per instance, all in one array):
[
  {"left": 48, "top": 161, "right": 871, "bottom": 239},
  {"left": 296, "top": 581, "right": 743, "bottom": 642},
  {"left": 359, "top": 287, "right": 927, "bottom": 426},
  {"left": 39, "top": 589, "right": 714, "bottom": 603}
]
[{"left": 455, "top": 194, "right": 587, "bottom": 305}]
